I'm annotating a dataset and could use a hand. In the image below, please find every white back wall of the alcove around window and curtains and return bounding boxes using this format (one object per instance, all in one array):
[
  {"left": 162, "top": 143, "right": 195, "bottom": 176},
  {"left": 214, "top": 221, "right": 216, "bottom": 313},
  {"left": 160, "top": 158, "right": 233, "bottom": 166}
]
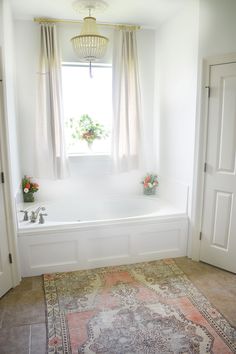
[{"left": 15, "top": 21, "right": 155, "bottom": 199}]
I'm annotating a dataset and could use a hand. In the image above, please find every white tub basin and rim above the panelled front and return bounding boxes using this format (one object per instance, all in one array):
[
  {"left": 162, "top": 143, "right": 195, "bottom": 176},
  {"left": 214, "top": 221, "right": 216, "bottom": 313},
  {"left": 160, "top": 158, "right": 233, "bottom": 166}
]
[{"left": 17, "top": 196, "right": 185, "bottom": 228}]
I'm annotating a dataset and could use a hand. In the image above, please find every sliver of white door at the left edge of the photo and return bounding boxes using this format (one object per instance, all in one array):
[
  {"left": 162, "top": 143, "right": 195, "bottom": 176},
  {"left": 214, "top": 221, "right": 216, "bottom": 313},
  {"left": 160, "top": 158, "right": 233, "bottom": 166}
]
[{"left": 0, "top": 82, "right": 12, "bottom": 297}]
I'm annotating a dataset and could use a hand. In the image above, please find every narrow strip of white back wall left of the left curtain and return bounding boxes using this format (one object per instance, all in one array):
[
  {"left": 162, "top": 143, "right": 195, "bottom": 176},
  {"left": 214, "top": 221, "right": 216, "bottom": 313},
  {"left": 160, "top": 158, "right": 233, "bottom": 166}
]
[{"left": 15, "top": 21, "right": 40, "bottom": 180}]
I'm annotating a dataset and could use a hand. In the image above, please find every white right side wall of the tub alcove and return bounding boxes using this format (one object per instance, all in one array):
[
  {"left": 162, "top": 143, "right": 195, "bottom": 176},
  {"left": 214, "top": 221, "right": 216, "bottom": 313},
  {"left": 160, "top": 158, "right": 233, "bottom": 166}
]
[{"left": 155, "top": 0, "right": 198, "bottom": 210}]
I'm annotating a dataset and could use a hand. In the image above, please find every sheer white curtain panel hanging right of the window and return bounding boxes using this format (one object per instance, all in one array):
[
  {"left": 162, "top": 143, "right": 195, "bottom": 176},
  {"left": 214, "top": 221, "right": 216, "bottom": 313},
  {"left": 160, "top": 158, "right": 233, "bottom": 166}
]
[{"left": 112, "top": 29, "right": 141, "bottom": 172}]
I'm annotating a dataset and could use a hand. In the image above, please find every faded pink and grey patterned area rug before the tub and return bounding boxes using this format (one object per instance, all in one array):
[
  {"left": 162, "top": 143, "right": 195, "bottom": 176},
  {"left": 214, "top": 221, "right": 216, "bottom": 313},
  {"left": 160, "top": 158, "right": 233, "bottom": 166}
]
[{"left": 44, "top": 259, "right": 236, "bottom": 354}]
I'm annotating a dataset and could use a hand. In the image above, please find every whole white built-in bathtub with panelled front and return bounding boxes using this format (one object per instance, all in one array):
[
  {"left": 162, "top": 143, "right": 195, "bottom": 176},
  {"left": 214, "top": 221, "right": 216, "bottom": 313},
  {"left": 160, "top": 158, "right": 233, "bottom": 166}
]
[{"left": 18, "top": 196, "right": 188, "bottom": 276}]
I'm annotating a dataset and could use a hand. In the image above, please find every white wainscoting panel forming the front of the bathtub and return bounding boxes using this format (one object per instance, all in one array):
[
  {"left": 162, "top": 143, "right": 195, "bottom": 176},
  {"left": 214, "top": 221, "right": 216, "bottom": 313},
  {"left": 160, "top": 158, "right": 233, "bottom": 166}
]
[{"left": 18, "top": 216, "right": 188, "bottom": 277}]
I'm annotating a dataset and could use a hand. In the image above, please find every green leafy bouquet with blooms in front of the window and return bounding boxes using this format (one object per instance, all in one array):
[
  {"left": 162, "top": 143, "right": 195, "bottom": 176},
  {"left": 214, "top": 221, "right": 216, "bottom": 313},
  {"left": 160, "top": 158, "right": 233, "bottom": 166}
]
[{"left": 67, "top": 114, "right": 109, "bottom": 145}]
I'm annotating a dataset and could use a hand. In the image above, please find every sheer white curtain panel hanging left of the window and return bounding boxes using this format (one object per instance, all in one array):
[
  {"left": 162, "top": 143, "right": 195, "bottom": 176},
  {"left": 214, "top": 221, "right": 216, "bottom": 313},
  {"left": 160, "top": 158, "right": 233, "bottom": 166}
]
[{"left": 35, "top": 24, "right": 68, "bottom": 179}]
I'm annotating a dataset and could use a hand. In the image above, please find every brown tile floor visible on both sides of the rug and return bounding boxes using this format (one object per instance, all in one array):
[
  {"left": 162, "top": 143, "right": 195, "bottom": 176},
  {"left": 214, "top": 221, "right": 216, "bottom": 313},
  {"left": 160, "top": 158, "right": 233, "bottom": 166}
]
[{"left": 0, "top": 257, "right": 236, "bottom": 354}]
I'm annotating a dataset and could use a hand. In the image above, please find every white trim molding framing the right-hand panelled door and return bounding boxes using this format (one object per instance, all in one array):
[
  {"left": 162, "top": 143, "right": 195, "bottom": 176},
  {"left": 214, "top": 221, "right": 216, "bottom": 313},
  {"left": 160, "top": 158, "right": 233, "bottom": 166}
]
[{"left": 190, "top": 53, "right": 236, "bottom": 261}]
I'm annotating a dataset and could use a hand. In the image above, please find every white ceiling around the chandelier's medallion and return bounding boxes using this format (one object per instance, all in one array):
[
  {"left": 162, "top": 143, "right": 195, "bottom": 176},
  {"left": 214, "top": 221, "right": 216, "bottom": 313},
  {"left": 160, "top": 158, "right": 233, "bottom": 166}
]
[{"left": 9, "top": 0, "right": 191, "bottom": 28}]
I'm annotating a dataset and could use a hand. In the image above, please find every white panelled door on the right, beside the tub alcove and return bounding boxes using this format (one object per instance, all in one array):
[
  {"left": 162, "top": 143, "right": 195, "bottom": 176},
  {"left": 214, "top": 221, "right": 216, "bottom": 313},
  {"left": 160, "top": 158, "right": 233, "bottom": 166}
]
[{"left": 200, "top": 63, "right": 236, "bottom": 273}]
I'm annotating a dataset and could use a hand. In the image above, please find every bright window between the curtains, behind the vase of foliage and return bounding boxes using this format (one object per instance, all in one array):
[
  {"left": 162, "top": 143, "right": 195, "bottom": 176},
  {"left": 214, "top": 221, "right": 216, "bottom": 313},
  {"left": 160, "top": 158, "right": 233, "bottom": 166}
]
[{"left": 62, "top": 64, "right": 112, "bottom": 155}]
